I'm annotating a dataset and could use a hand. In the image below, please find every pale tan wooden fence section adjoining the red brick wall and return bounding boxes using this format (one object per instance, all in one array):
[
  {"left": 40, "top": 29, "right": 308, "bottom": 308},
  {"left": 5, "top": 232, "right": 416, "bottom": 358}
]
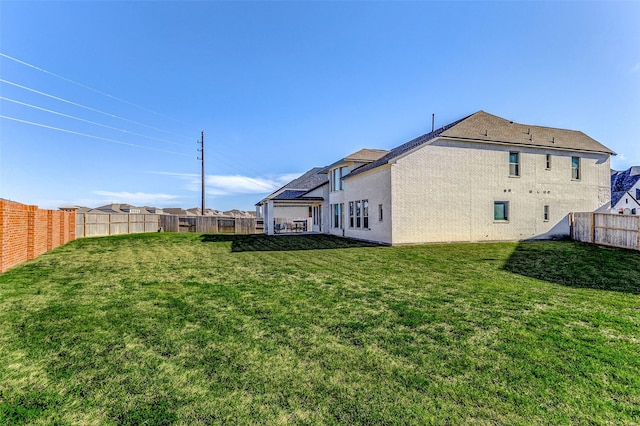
[{"left": 76, "top": 213, "right": 160, "bottom": 238}]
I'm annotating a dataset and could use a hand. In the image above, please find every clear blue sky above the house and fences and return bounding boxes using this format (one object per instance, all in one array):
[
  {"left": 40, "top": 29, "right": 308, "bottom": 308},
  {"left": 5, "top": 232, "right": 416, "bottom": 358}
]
[{"left": 0, "top": 0, "right": 640, "bottom": 210}]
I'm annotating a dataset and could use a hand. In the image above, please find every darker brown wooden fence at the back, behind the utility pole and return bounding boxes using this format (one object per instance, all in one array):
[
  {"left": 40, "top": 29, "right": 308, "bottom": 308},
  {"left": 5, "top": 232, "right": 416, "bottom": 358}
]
[{"left": 159, "top": 215, "right": 258, "bottom": 234}]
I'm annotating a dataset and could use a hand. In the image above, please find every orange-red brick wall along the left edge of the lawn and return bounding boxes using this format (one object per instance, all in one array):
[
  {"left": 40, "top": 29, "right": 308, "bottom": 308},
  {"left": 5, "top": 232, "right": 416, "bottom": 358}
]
[{"left": 0, "top": 200, "right": 76, "bottom": 272}]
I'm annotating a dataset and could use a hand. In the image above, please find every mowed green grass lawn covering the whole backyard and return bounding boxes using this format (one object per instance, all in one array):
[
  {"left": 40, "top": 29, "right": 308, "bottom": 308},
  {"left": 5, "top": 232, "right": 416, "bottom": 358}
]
[{"left": 0, "top": 233, "right": 640, "bottom": 425}]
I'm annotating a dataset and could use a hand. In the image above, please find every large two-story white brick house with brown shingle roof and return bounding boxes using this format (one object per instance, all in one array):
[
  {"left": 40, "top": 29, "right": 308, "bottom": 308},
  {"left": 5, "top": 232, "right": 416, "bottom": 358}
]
[{"left": 255, "top": 111, "right": 614, "bottom": 244}]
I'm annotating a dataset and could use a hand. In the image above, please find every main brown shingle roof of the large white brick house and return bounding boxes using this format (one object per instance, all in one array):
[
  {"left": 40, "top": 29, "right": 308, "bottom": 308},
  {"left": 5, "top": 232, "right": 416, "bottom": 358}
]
[{"left": 345, "top": 111, "right": 615, "bottom": 179}]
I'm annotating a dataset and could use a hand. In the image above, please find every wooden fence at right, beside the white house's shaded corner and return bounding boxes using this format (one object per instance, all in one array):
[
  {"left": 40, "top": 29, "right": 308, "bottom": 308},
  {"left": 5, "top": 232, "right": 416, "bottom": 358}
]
[{"left": 571, "top": 212, "right": 640, "bottom": 250}]
